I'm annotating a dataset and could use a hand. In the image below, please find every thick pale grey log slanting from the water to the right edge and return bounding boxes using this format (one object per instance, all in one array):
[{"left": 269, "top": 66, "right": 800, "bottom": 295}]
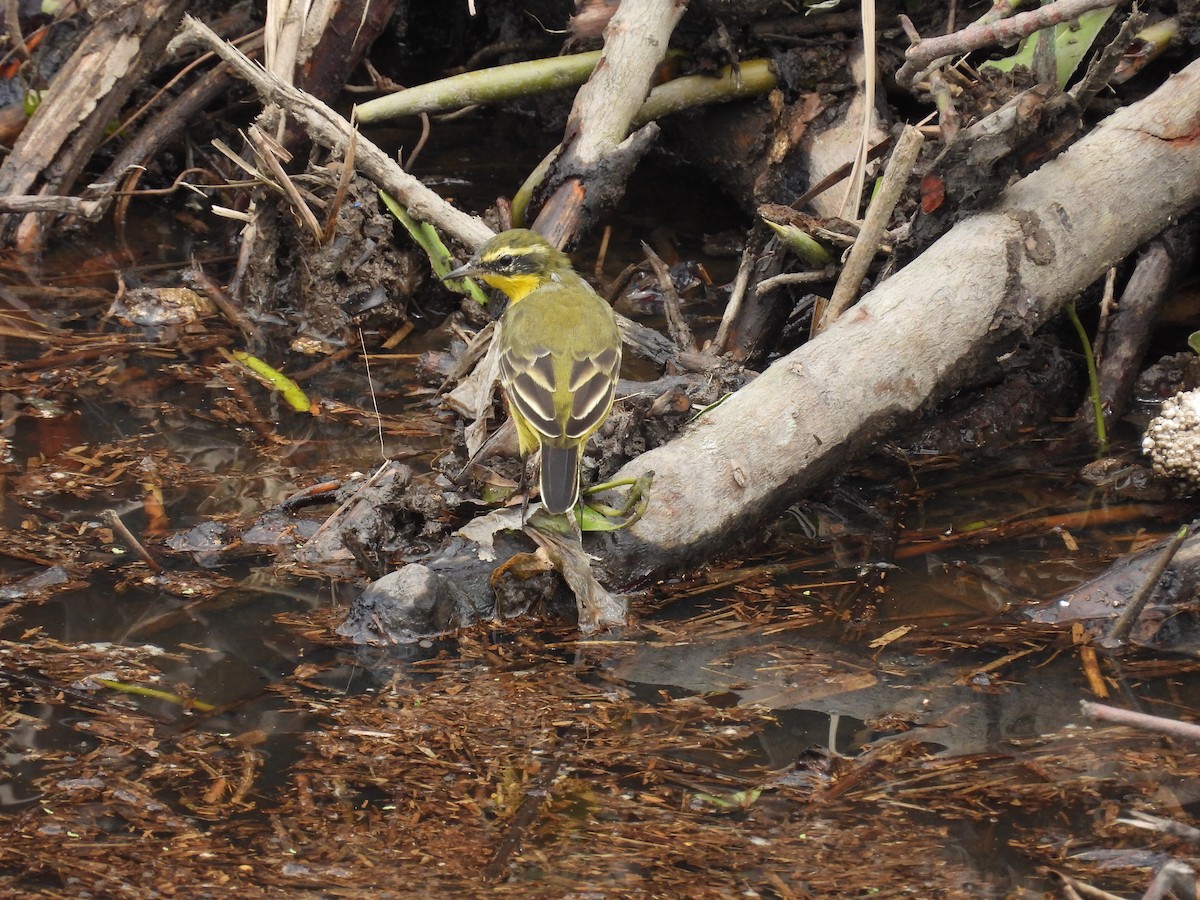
[{"left": 598, "top": 62, "right": 1200, "bottom": 592}]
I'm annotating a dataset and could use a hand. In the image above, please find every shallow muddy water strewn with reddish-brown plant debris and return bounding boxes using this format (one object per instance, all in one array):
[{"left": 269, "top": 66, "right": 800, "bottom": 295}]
[{"left": 0, "top": 125, "right": 1200, "bottom": 896}]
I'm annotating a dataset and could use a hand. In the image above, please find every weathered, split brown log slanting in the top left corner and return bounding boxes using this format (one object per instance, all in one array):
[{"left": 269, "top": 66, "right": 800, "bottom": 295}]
[{"left": 0, "top": 0, "right": 187, "bottom": 247}]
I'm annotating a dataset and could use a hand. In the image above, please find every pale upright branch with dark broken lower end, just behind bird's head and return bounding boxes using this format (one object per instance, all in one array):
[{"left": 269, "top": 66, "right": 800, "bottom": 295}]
[{"left": 533, "top": 0, "right": 688, "bottom": 247}]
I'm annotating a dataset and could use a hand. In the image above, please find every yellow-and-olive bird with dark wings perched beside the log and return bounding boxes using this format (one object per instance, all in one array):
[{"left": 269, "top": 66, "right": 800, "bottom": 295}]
[{"left": 444, "top": 228, "right": 620, "bottom": 514}]
